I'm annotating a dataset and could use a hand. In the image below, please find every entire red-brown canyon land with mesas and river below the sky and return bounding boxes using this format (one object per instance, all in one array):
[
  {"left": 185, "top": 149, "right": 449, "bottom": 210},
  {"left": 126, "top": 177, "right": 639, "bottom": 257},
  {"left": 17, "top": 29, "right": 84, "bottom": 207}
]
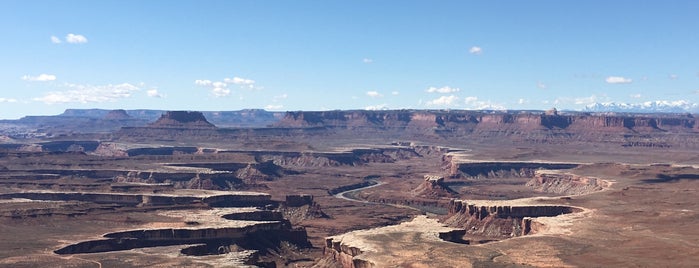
[{"left": 0, "top": 110, "right": 699, "bottom": 267}]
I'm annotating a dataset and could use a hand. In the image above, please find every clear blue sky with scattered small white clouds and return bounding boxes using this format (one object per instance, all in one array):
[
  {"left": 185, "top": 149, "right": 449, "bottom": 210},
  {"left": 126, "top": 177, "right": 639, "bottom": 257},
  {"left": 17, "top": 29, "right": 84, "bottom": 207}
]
[{"left": 0, "top": 0, "right": 699, "bottom": 119}]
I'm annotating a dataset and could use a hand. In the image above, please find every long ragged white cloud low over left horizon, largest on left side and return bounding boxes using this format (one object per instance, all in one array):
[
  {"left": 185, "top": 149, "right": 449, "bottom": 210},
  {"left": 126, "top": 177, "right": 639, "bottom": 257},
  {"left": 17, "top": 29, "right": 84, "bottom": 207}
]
[{"left": 33, "top": 83, "right": 140, "bottom": 104}]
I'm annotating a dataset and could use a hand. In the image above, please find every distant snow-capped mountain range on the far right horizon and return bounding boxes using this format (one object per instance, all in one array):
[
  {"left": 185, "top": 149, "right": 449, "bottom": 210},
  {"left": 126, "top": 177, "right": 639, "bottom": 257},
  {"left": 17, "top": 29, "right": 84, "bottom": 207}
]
[{"left": 584, "top": 100, "right": 699, "bottom": 113}]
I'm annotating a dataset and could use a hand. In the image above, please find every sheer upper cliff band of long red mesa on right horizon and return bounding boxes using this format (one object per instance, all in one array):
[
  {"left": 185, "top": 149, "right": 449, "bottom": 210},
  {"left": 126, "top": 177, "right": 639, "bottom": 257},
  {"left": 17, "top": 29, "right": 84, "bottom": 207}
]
[{"left": 276, "top": 110, "right": 696, "bottom": 131}]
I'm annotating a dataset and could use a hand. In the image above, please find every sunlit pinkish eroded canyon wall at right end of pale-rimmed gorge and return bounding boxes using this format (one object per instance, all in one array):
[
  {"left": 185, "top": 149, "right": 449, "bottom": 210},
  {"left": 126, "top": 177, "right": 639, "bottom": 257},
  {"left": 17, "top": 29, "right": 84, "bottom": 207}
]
[{"left": 526, "top": 171, "right": 610, "bottom": 195}]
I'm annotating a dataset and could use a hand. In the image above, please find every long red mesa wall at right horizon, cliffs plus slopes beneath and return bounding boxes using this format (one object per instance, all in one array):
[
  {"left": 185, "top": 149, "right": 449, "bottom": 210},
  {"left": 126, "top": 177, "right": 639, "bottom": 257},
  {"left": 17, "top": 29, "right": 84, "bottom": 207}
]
[{"left": 274, "top": 110, "right": 699, "bottom": 148}]
